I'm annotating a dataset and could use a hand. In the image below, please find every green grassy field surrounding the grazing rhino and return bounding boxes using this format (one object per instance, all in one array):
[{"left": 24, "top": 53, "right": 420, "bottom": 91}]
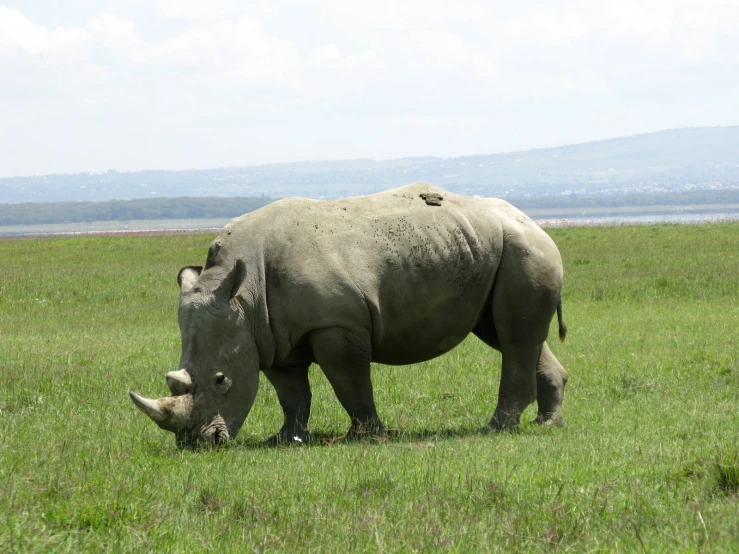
[{"left": 0, "top": 223, "right": 739, "bottom": 553}]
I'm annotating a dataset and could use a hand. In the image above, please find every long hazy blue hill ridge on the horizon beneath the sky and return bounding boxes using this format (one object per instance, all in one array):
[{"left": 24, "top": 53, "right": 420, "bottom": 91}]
[{"left": 0, "top": 126, "right": 739, "bottom": 203}]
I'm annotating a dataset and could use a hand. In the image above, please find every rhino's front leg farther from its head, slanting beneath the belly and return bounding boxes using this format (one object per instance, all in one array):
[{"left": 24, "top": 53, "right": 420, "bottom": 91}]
[{"left": 309, "top": 328, "right": 385, "bottom": 438}]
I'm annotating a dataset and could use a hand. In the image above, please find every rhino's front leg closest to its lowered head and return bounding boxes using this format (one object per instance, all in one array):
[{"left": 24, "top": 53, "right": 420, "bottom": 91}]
[{"left": 264, "top": 365, "right": 311, "bottom": 444}]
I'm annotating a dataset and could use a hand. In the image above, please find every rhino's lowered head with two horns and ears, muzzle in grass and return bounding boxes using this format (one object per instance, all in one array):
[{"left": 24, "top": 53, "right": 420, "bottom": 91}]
[{"left": 130, "top": 261, "right": 259, "bottom": 447}]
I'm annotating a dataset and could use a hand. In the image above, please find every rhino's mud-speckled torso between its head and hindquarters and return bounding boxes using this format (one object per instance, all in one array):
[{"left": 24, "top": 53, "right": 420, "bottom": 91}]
[{"left": 212, "top": 183, "right": 538, "bottom": 364}]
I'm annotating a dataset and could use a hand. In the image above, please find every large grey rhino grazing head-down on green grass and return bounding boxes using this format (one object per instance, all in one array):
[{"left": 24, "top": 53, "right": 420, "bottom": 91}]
[{"left": 130, "top": 183, "right": 567, "bottom": 447}]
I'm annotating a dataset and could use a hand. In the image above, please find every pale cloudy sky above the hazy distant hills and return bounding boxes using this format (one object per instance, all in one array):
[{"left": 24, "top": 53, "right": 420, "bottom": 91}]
[{"left": 0, "top": 0, "right": 739, "bottom": 177}]
